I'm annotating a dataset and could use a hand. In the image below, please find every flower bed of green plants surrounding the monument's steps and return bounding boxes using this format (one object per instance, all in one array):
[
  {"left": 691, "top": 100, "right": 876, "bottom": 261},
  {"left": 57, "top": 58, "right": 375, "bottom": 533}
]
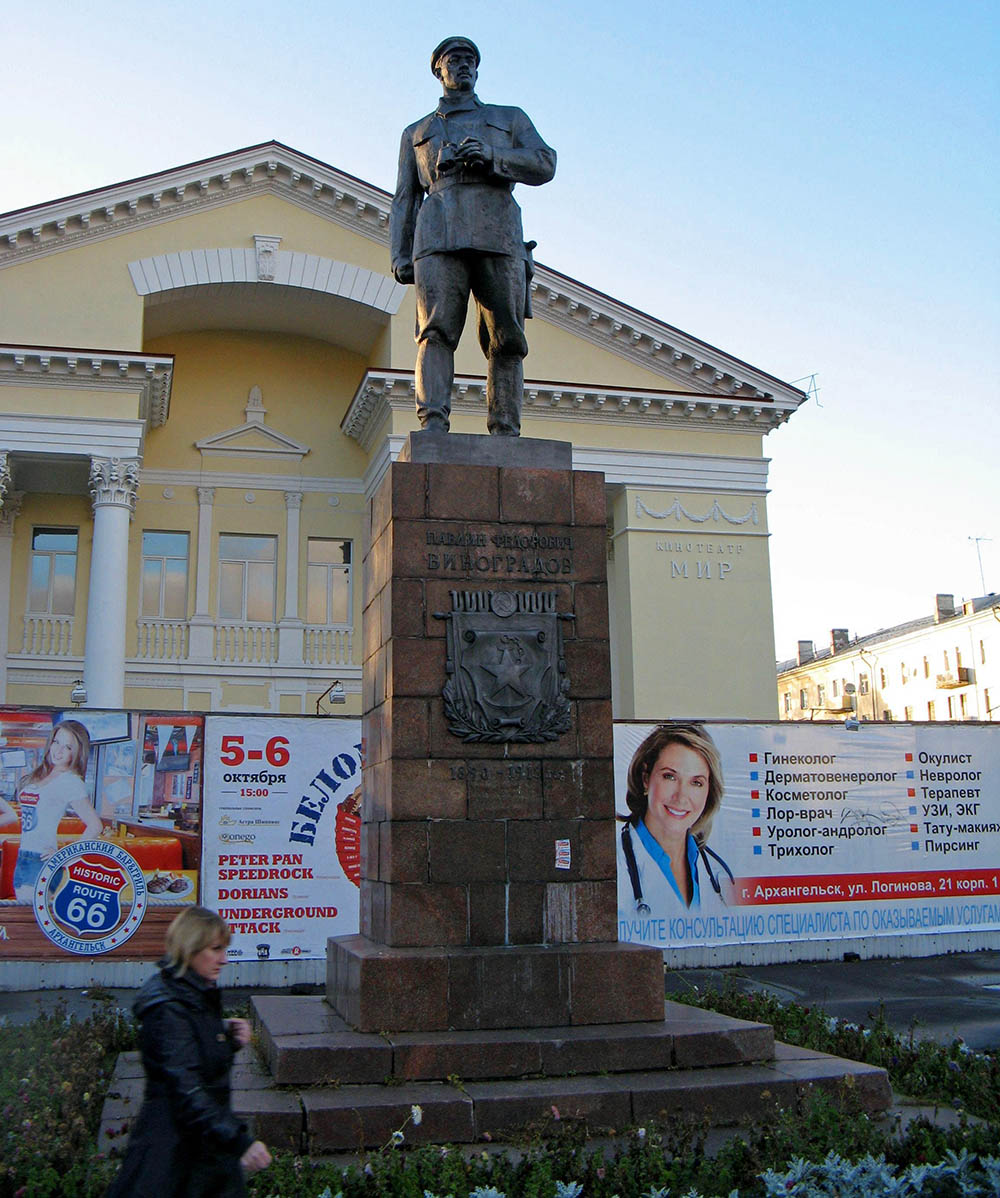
[{"left": 0, "top": 992, "right": 1000, "bottom": 1198}]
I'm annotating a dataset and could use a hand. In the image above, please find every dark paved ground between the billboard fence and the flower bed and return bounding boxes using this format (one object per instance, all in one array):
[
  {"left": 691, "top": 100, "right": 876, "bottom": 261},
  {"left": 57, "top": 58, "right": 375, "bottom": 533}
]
[{"left": 0, "top": 950, "right": 1000, "bottom": 1049}]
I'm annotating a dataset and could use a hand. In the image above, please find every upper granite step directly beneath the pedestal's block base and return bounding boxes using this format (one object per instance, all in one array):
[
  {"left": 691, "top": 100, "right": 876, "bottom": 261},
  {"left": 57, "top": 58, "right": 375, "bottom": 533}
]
[{"left": 251, "top": 996, "right": 774, "bottom": 1085}]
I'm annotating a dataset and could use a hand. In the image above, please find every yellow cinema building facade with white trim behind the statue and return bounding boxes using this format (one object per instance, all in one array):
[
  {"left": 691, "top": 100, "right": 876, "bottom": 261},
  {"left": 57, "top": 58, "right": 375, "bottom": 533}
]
[{"left": 0, "top": 143, "right": 805, "bottom": 719}]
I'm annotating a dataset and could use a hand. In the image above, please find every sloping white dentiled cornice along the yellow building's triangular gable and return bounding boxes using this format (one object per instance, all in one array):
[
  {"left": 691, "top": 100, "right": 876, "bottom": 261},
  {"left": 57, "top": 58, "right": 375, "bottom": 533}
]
[{"left": 0, "top": 141, "right": 806, "bottom": 413}]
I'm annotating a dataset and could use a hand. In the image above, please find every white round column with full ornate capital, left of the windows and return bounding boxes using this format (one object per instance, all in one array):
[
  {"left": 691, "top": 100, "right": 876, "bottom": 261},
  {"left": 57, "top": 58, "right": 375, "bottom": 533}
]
[{"left": 84, "top": 458, "right": 139, "bottom": 707}]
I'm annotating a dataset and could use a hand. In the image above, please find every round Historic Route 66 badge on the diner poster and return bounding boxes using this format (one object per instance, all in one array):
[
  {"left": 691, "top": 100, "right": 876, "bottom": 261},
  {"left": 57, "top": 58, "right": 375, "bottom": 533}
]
[{"left": 34, "top": 840, "right": 146, "bottom": 956}]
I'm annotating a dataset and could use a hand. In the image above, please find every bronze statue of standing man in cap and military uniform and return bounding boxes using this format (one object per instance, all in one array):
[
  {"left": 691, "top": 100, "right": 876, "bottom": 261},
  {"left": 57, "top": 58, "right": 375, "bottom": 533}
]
[{"left": 389, "top": 37, "right": 556, "bottom": 437}]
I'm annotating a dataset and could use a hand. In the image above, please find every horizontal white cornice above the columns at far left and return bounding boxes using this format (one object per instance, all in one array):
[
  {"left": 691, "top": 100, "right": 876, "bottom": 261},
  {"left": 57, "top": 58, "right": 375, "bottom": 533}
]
[{"left": 0, "top": 345, "right": 174, "bottom": 429}]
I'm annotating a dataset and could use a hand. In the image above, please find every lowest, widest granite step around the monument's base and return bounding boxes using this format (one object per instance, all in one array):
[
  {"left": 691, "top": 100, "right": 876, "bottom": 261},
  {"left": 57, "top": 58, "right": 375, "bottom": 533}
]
[{"left": 101, "top": 1045, "right": 892, "bottom": 1156}]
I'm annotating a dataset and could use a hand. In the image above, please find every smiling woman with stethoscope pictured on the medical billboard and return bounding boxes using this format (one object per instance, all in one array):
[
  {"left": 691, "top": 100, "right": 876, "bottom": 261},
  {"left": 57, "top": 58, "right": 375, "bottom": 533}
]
[{"left": 618, "top": 724, "right": 733, "bottom": 915}]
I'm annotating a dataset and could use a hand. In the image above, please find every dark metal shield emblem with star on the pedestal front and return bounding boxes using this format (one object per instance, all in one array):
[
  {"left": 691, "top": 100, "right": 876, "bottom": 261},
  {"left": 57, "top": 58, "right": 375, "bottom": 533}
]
[{"left": 435, "top": 591, "right": 574, "bottom": 744}]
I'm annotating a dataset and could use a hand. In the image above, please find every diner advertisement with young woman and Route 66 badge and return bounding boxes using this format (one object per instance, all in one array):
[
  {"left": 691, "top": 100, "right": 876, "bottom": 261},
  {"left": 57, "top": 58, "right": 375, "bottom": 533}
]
[{"left": 0, "top": 708, "right": 204, "bottom": 958}]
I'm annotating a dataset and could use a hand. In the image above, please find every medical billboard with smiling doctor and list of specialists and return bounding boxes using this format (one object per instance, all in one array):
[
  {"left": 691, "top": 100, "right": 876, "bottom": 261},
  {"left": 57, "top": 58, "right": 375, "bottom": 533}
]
[{"left": 614, "top": 720, "right": 1000, "bottom": 948}]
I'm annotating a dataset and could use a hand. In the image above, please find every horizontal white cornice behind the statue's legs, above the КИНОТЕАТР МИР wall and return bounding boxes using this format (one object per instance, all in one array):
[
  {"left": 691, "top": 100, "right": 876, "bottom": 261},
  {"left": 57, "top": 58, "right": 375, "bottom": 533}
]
[{"left": 341, "top": 370, "right": 796, "bottom": 453}]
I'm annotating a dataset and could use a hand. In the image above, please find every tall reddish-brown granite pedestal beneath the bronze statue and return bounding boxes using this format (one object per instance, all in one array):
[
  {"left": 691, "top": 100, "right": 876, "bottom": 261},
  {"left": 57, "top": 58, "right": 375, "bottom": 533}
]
[{"left": 327, "top": 434, "right": 662, "bottom": 1031}]
